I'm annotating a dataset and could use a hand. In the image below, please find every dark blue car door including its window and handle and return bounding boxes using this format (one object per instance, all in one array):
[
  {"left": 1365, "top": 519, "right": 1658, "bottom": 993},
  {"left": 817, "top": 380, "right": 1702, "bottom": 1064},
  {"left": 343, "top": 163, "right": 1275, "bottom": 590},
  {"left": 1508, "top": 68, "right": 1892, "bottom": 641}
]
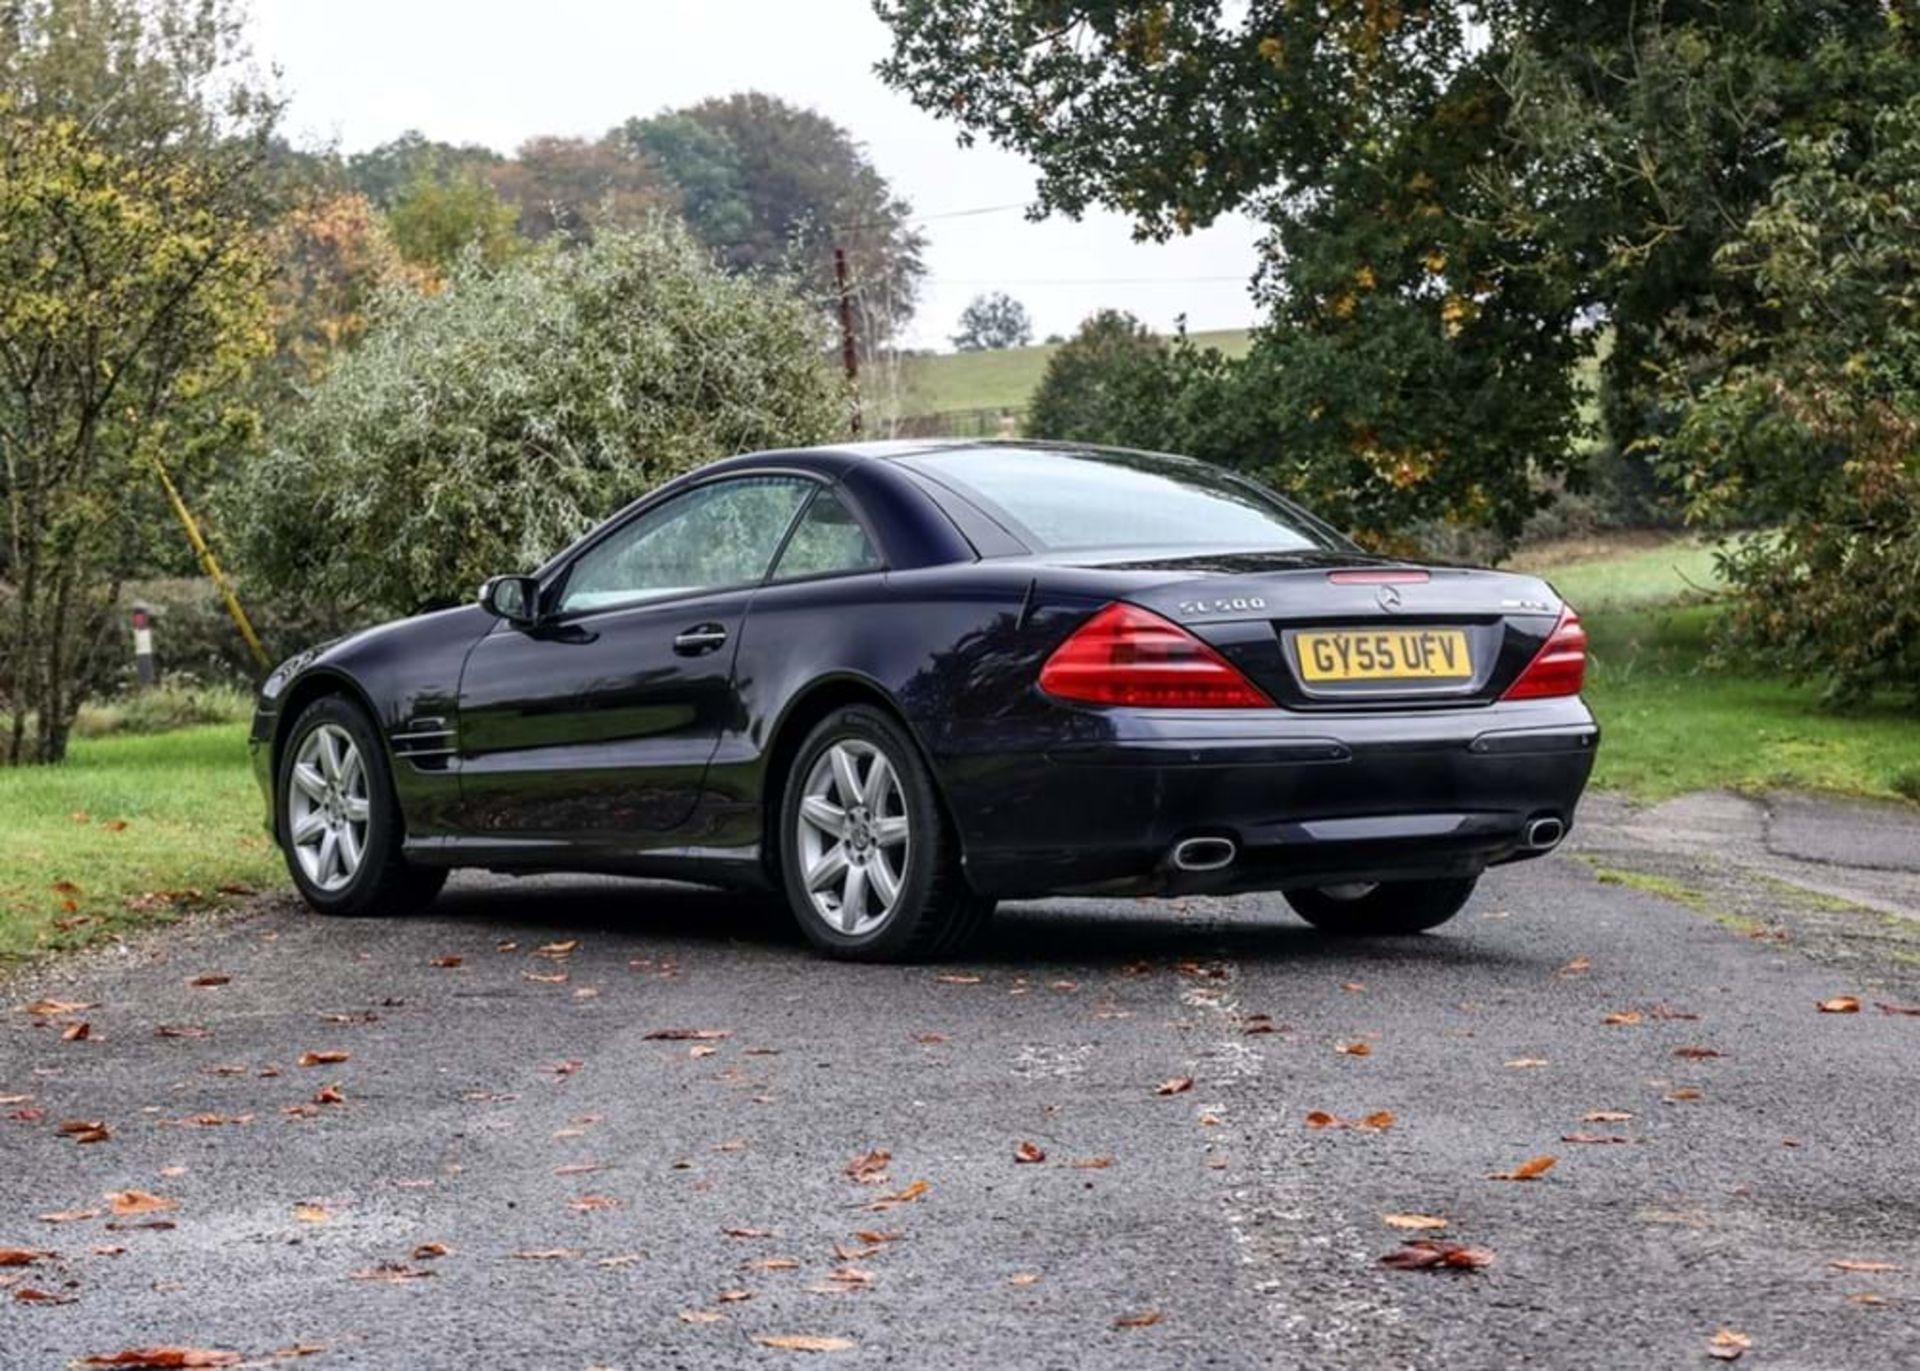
[{"left": 459, "top": 474, "right": 816, "bottom": 849}]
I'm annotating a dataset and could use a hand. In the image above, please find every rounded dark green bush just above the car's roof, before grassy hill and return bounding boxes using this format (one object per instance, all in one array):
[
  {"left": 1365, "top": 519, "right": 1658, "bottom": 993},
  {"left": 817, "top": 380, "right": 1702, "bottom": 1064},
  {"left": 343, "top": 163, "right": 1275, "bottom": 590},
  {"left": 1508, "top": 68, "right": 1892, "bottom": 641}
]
[{"left": 1025, "top": 309, "right": 1177, "bottom": 447}]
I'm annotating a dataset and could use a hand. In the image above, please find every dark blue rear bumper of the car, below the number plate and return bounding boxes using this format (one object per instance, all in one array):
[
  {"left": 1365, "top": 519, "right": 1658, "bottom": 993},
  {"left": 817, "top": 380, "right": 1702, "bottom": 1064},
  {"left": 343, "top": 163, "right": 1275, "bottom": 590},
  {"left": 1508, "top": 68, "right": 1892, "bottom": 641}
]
[{"left": 939, "top": 699, "right": 1599, "bottom": 899}]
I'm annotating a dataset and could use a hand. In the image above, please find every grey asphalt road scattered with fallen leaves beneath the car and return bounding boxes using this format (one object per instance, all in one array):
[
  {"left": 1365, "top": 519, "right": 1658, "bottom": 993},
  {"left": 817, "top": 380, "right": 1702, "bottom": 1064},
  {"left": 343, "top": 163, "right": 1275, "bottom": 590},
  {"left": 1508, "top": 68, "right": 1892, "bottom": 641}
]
[{"left": 0, "top": 837, "right": 1920, "bottom": 1367}]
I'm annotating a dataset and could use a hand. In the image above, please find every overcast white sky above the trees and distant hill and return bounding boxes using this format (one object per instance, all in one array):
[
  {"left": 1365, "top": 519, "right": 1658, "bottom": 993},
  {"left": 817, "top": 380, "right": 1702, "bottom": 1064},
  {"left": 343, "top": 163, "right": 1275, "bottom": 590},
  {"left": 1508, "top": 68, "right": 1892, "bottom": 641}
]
[{"left": 253, "top": 0, "right": 1260, "bottom": 348}]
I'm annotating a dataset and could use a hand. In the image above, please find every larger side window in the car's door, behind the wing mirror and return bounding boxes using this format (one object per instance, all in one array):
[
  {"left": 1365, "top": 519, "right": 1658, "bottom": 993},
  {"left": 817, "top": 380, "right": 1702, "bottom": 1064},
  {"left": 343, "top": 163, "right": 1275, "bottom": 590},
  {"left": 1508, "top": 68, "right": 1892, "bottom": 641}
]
[{"left": 561, "top": 476, "right": 814, "bottom": 614}]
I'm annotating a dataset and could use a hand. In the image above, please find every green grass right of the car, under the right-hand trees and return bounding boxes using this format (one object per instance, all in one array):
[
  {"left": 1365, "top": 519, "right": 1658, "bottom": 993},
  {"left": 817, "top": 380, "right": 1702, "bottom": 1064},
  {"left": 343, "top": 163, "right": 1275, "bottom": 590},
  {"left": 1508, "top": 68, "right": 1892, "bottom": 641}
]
[{"left": 1515, "top": 538, "right": 1920, "bottom": 799}]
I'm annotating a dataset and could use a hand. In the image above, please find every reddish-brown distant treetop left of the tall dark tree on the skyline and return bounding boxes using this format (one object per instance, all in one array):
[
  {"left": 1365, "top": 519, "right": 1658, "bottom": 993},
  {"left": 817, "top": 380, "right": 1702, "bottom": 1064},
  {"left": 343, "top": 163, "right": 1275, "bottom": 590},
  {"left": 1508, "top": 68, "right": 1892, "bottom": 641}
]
[{"left": 492, "top": 138, "right": 676, "bottom": 242}]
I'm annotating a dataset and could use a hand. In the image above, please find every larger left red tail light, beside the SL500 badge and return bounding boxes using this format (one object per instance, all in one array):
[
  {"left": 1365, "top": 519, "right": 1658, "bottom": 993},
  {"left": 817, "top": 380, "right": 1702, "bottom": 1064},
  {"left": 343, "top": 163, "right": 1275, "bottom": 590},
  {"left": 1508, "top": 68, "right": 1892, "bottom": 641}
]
[{"left": 1041, "top": 601, "right": 1273, "bottom": 709}]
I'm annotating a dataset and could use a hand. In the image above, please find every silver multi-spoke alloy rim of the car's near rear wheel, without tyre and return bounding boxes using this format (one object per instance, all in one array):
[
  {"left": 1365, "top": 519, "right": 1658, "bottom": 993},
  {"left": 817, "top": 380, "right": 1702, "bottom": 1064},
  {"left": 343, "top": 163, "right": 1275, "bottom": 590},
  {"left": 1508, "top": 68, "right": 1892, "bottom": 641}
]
[{"left": 795, "top": 737, "right": 912, "bottom": 937}]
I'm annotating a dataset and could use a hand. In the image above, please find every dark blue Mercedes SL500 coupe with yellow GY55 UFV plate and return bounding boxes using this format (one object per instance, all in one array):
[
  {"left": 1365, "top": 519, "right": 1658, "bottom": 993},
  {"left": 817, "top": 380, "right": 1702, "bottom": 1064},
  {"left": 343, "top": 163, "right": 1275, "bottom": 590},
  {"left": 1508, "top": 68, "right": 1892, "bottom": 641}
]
[{"left": 253, "top": 442, "right": 1597, "bottom": 960}]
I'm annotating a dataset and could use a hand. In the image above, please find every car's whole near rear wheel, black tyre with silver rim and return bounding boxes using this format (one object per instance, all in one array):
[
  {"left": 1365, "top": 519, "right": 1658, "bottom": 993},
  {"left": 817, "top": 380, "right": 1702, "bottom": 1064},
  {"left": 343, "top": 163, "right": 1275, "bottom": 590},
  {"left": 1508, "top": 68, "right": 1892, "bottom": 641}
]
[{"left": 780, "top": 705, "right": 993, "bottom": 962}]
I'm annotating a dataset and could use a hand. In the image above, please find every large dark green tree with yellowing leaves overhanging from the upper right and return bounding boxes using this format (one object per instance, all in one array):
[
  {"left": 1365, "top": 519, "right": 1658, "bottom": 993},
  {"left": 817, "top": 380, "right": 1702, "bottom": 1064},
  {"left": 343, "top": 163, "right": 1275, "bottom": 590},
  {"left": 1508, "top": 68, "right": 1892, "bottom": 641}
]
[{"left": 879, "top": 0, "right": 1920, "bottom": 538}]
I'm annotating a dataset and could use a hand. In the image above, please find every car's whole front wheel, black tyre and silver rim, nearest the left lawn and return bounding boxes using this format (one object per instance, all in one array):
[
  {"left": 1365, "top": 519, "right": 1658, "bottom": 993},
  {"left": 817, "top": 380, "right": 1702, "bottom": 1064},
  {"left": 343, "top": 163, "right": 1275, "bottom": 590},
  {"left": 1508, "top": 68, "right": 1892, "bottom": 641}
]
[{"left": 275, "top": 695, "right": 447, "bottom": 916}]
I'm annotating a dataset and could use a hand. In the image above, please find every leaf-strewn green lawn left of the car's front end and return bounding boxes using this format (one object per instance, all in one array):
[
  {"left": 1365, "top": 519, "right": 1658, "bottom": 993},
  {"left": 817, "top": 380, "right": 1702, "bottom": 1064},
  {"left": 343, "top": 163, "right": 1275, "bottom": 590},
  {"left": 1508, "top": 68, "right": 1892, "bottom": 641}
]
[{"left": 0, "top": 724, "right": 284, "bottom": 962}]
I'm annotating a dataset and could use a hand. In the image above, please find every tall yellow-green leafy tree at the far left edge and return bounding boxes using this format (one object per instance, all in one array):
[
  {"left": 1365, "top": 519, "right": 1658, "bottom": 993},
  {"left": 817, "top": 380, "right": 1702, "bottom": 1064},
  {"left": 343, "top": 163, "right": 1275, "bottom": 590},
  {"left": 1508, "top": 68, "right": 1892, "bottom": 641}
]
[{"left": 0, "top": 0, "right": 278, "bottom": 764}]
